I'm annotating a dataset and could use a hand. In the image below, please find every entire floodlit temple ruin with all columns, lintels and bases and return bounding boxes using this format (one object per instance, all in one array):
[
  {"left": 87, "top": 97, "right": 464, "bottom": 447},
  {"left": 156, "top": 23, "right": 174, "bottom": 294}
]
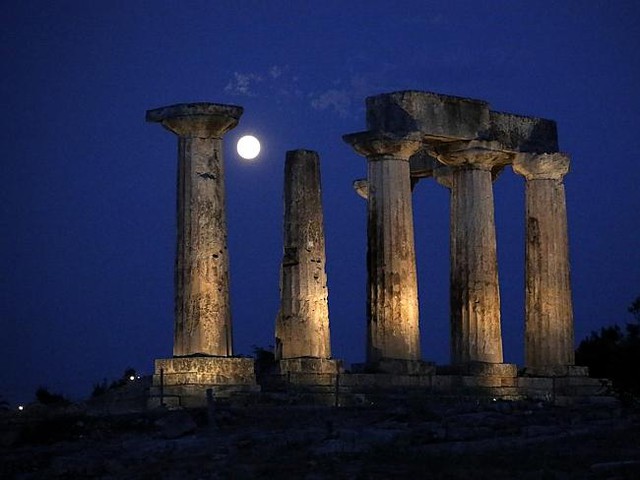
[{"left": 147, "top": 91, "right": 599, "bottom": 405}]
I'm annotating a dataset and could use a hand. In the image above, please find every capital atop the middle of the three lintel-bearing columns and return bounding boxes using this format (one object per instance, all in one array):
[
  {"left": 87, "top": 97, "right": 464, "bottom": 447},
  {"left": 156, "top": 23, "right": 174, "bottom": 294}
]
[{"left": 430, "top": 140, "right": 515, "bottom": 170}]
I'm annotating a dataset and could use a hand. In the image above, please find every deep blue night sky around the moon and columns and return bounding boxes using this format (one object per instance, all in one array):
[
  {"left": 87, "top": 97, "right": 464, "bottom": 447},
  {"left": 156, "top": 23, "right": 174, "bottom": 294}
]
[{"left": 0, "top": 0, "right": 640, "bottom": 402}]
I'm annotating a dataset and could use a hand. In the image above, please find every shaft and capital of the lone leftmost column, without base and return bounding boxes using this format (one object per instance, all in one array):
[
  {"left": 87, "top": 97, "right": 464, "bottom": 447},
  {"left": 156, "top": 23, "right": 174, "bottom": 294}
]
[{"left": 146, "top": 103, "right": 242, "bottom": 356}]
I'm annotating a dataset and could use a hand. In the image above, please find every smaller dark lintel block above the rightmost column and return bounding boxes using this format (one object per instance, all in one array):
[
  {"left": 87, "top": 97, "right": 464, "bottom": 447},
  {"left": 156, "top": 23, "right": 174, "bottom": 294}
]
[{"left": 488, "top": 112, "right": 558, "bottom": 153}]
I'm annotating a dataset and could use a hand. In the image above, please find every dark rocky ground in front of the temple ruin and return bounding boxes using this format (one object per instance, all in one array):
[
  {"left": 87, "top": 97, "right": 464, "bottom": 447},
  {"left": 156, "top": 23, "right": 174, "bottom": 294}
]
[{"left": 0, "top": 399, "right": 640, "bottom": 480}]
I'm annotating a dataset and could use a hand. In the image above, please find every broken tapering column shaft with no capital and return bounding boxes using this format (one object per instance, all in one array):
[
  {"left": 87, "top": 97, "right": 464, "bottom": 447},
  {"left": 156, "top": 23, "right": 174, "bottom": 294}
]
[{"left": 276, "top": 150, "right": 331, "bottom": 360}]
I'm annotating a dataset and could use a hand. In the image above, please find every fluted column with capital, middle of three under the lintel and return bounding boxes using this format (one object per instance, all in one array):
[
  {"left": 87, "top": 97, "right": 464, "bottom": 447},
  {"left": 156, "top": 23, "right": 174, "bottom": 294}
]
[{"left": 433, "top": 141, "right": 511, "bottom": 365}]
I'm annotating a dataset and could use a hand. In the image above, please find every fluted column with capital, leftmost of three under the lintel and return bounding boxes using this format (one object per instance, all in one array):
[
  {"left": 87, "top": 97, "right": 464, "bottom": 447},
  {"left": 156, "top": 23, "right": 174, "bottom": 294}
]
[{"left": 343, "top": 132, "right": 422, "bottom": 364}]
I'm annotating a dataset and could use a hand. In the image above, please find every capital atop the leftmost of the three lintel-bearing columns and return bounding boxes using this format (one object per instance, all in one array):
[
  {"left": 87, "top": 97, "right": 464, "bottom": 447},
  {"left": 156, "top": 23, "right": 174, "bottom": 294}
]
[{"left": 342, "top": 130, "right": 423, "bottom": 160}]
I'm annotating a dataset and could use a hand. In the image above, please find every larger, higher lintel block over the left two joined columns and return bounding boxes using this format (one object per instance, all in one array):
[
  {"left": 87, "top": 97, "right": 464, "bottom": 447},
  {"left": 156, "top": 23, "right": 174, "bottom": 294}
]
[{"left": 366, "top": 90, "right": 490, "bottom": 141}]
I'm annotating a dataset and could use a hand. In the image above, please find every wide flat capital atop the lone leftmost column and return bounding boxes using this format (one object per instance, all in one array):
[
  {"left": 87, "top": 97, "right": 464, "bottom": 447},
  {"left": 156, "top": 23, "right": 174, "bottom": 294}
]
[{"left": 146, "top": 103, "right": 243, "bottom": 138}]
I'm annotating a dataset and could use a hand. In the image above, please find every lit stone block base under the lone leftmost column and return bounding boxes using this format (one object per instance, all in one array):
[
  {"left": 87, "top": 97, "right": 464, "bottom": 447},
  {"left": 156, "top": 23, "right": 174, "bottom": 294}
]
[{"left": 148, "top": 356, "right": 260, "bottom": 408}]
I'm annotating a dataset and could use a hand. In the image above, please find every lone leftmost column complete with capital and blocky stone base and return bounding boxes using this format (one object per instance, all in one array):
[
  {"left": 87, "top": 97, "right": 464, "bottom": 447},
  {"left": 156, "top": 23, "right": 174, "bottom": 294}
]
[{"left": 146, "top": 103, "right": 255, "bottom": 406}]
